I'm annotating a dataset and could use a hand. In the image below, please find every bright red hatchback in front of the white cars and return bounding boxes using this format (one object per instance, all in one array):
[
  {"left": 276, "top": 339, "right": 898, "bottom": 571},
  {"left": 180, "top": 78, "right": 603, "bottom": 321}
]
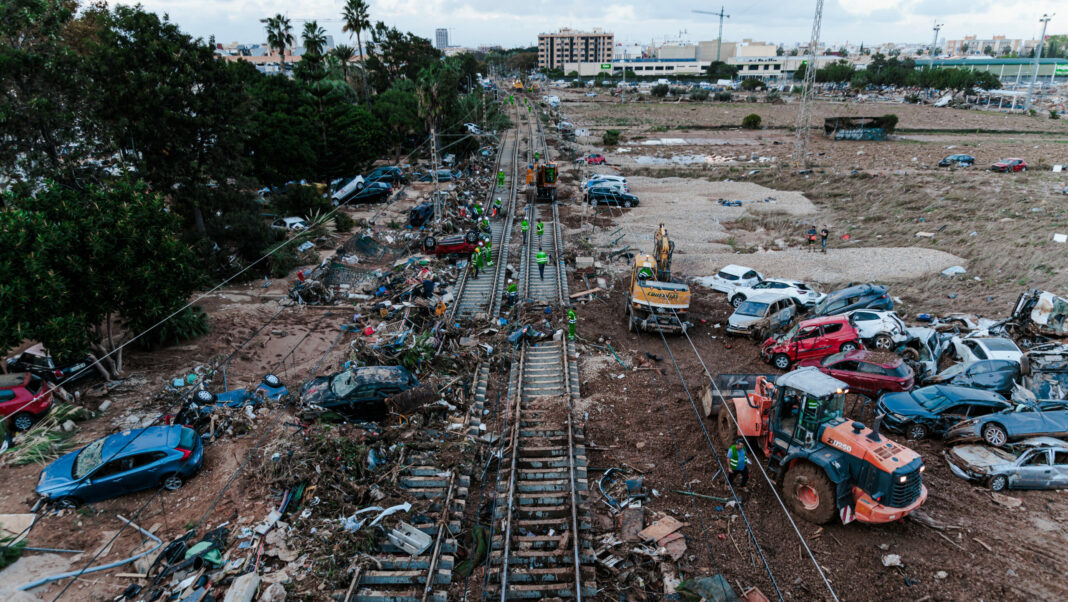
[{"left": 760, "top": 316, "right": 861, "bottom": 370}]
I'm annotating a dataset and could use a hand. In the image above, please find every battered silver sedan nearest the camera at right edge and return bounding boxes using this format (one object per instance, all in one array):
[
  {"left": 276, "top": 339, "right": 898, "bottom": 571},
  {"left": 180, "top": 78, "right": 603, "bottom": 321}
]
[{"left": 944, "top": 437, "right": 1068, "bottom": 491}]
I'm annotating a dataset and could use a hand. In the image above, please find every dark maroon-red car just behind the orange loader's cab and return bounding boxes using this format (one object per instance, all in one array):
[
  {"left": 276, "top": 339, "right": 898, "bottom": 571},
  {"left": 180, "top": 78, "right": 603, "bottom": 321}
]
[{"left": 799, "top": 349, "right": 915, "bottom": 399}]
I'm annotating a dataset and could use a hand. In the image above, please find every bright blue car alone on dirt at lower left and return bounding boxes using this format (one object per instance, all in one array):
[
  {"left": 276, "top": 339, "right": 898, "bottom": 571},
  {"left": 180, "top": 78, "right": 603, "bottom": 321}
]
[{"left": 37, "top": 425, "right": 204, "bottom": 508}]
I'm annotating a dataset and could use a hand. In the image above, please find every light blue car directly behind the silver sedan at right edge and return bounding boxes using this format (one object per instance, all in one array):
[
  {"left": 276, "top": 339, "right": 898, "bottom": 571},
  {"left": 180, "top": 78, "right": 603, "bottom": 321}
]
[{"left": 945, "top": 401, "right": 1068, "bottom": 447}]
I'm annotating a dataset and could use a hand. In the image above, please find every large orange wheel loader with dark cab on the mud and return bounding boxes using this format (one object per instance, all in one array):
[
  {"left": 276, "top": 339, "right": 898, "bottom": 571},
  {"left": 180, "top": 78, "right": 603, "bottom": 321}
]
[{"left": 717, "top": 366, "right": 927, "bottom": 524}]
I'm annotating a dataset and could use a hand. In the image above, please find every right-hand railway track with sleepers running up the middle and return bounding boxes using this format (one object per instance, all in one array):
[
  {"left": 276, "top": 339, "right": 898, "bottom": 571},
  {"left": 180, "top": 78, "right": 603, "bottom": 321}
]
[{"left": 484, "top": 97, "right": 597, "bottom": 601}]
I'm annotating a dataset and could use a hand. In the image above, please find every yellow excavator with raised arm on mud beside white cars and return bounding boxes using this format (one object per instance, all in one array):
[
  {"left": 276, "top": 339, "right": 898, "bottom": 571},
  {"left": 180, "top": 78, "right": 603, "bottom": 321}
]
[{"left": 624, "top": 224, "right": 692, "bottom": 333}]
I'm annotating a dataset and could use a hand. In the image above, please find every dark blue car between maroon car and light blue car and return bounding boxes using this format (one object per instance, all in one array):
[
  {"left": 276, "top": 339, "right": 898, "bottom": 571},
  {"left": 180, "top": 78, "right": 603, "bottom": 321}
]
[{"left": 878, "top": 384, "right": 1012, "bottom": 439}]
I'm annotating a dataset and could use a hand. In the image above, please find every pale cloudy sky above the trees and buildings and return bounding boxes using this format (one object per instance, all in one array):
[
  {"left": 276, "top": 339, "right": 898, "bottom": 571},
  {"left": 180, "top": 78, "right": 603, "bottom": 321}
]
[{"left": 122, "top": 0, "right": 1068, "bottom": 48}]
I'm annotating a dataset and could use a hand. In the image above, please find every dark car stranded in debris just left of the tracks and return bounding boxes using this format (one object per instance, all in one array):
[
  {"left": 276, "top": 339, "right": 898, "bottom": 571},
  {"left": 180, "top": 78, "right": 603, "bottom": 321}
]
[{"left": 300, "top": 366, "right": 419, "bottom": 418}]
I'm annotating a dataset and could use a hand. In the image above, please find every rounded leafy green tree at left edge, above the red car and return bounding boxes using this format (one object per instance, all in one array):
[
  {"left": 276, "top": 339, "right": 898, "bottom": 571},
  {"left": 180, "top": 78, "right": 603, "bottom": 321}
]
[{"left": 0, "top": 181, "right": 203, "bottom": 378}]
